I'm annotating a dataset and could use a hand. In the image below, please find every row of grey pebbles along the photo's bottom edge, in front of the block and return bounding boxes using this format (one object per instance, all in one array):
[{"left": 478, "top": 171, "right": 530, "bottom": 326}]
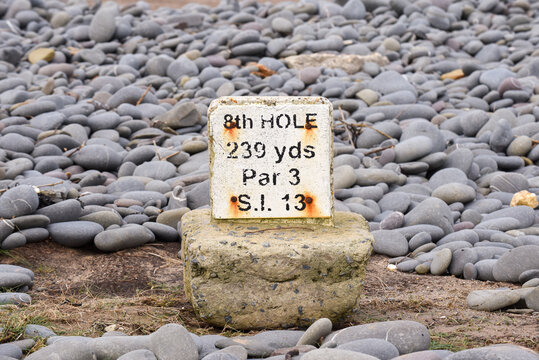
[{"left": 0, "top": 318, "right": 538, "bottom": 360}]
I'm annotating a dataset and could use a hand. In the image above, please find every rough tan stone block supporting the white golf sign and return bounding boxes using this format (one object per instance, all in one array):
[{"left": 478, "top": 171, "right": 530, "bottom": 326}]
[{"left": 181, "top": 210, "right": 374, "bottom": 329}]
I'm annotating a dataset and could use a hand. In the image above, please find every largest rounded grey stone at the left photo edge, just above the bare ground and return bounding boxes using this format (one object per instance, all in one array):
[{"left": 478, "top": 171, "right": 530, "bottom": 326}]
[{"left": 0, "top": 185, "right": 39, "bottom": 218}]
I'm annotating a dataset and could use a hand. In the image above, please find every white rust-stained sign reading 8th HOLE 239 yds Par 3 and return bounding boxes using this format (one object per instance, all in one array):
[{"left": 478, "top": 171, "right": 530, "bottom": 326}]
[{"left": 208, "top": 96, "right": 333, "bottom": 224}]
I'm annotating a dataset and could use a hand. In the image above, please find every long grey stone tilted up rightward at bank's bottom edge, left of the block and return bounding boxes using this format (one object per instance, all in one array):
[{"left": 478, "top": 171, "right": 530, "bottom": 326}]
[{"left": 94, "top": 224, "right": 155, "bottom": 252}]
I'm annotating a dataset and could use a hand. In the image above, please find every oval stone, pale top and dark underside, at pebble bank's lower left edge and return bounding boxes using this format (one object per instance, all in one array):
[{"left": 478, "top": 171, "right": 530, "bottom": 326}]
[{"left": 47, "top": 221, "right": 104, "bottom": 247}]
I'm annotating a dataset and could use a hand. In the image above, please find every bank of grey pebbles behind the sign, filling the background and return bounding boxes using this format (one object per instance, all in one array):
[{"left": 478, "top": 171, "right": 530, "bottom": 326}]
[{"left": 0, "top": 0, "right": 539, "bottom": 359}]
